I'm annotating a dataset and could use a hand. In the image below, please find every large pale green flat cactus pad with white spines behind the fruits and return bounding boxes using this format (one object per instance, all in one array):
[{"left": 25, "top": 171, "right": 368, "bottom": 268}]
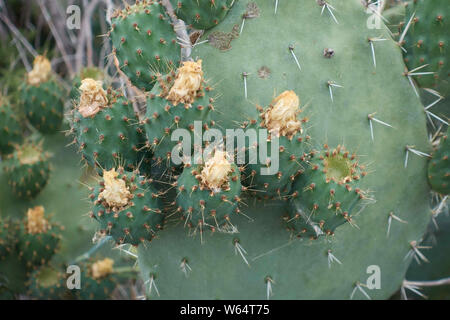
[{"left": 138, "top": 0, "right": 430, "bottom": 299}]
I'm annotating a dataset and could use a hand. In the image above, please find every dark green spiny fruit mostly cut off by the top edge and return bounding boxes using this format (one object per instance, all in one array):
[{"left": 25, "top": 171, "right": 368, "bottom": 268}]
[{"left": 171, "top": 0, "right": 235, "bottom": 30}]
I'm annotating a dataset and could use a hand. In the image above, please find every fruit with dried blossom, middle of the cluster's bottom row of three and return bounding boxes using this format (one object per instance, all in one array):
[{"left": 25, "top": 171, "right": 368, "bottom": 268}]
[{"left": 176, "top": 150, "right": 242, "bottom": 232}]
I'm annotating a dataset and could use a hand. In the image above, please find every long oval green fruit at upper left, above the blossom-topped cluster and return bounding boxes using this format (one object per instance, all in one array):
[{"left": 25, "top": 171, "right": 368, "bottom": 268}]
[{"left": 109, "top": 0, "right": 181, "bottom": 91}]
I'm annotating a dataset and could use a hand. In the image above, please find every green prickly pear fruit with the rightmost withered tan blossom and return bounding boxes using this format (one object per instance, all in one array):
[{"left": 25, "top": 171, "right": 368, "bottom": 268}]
[{"left": 245, "top": 91, "right": 309, "bottom": 199}]
